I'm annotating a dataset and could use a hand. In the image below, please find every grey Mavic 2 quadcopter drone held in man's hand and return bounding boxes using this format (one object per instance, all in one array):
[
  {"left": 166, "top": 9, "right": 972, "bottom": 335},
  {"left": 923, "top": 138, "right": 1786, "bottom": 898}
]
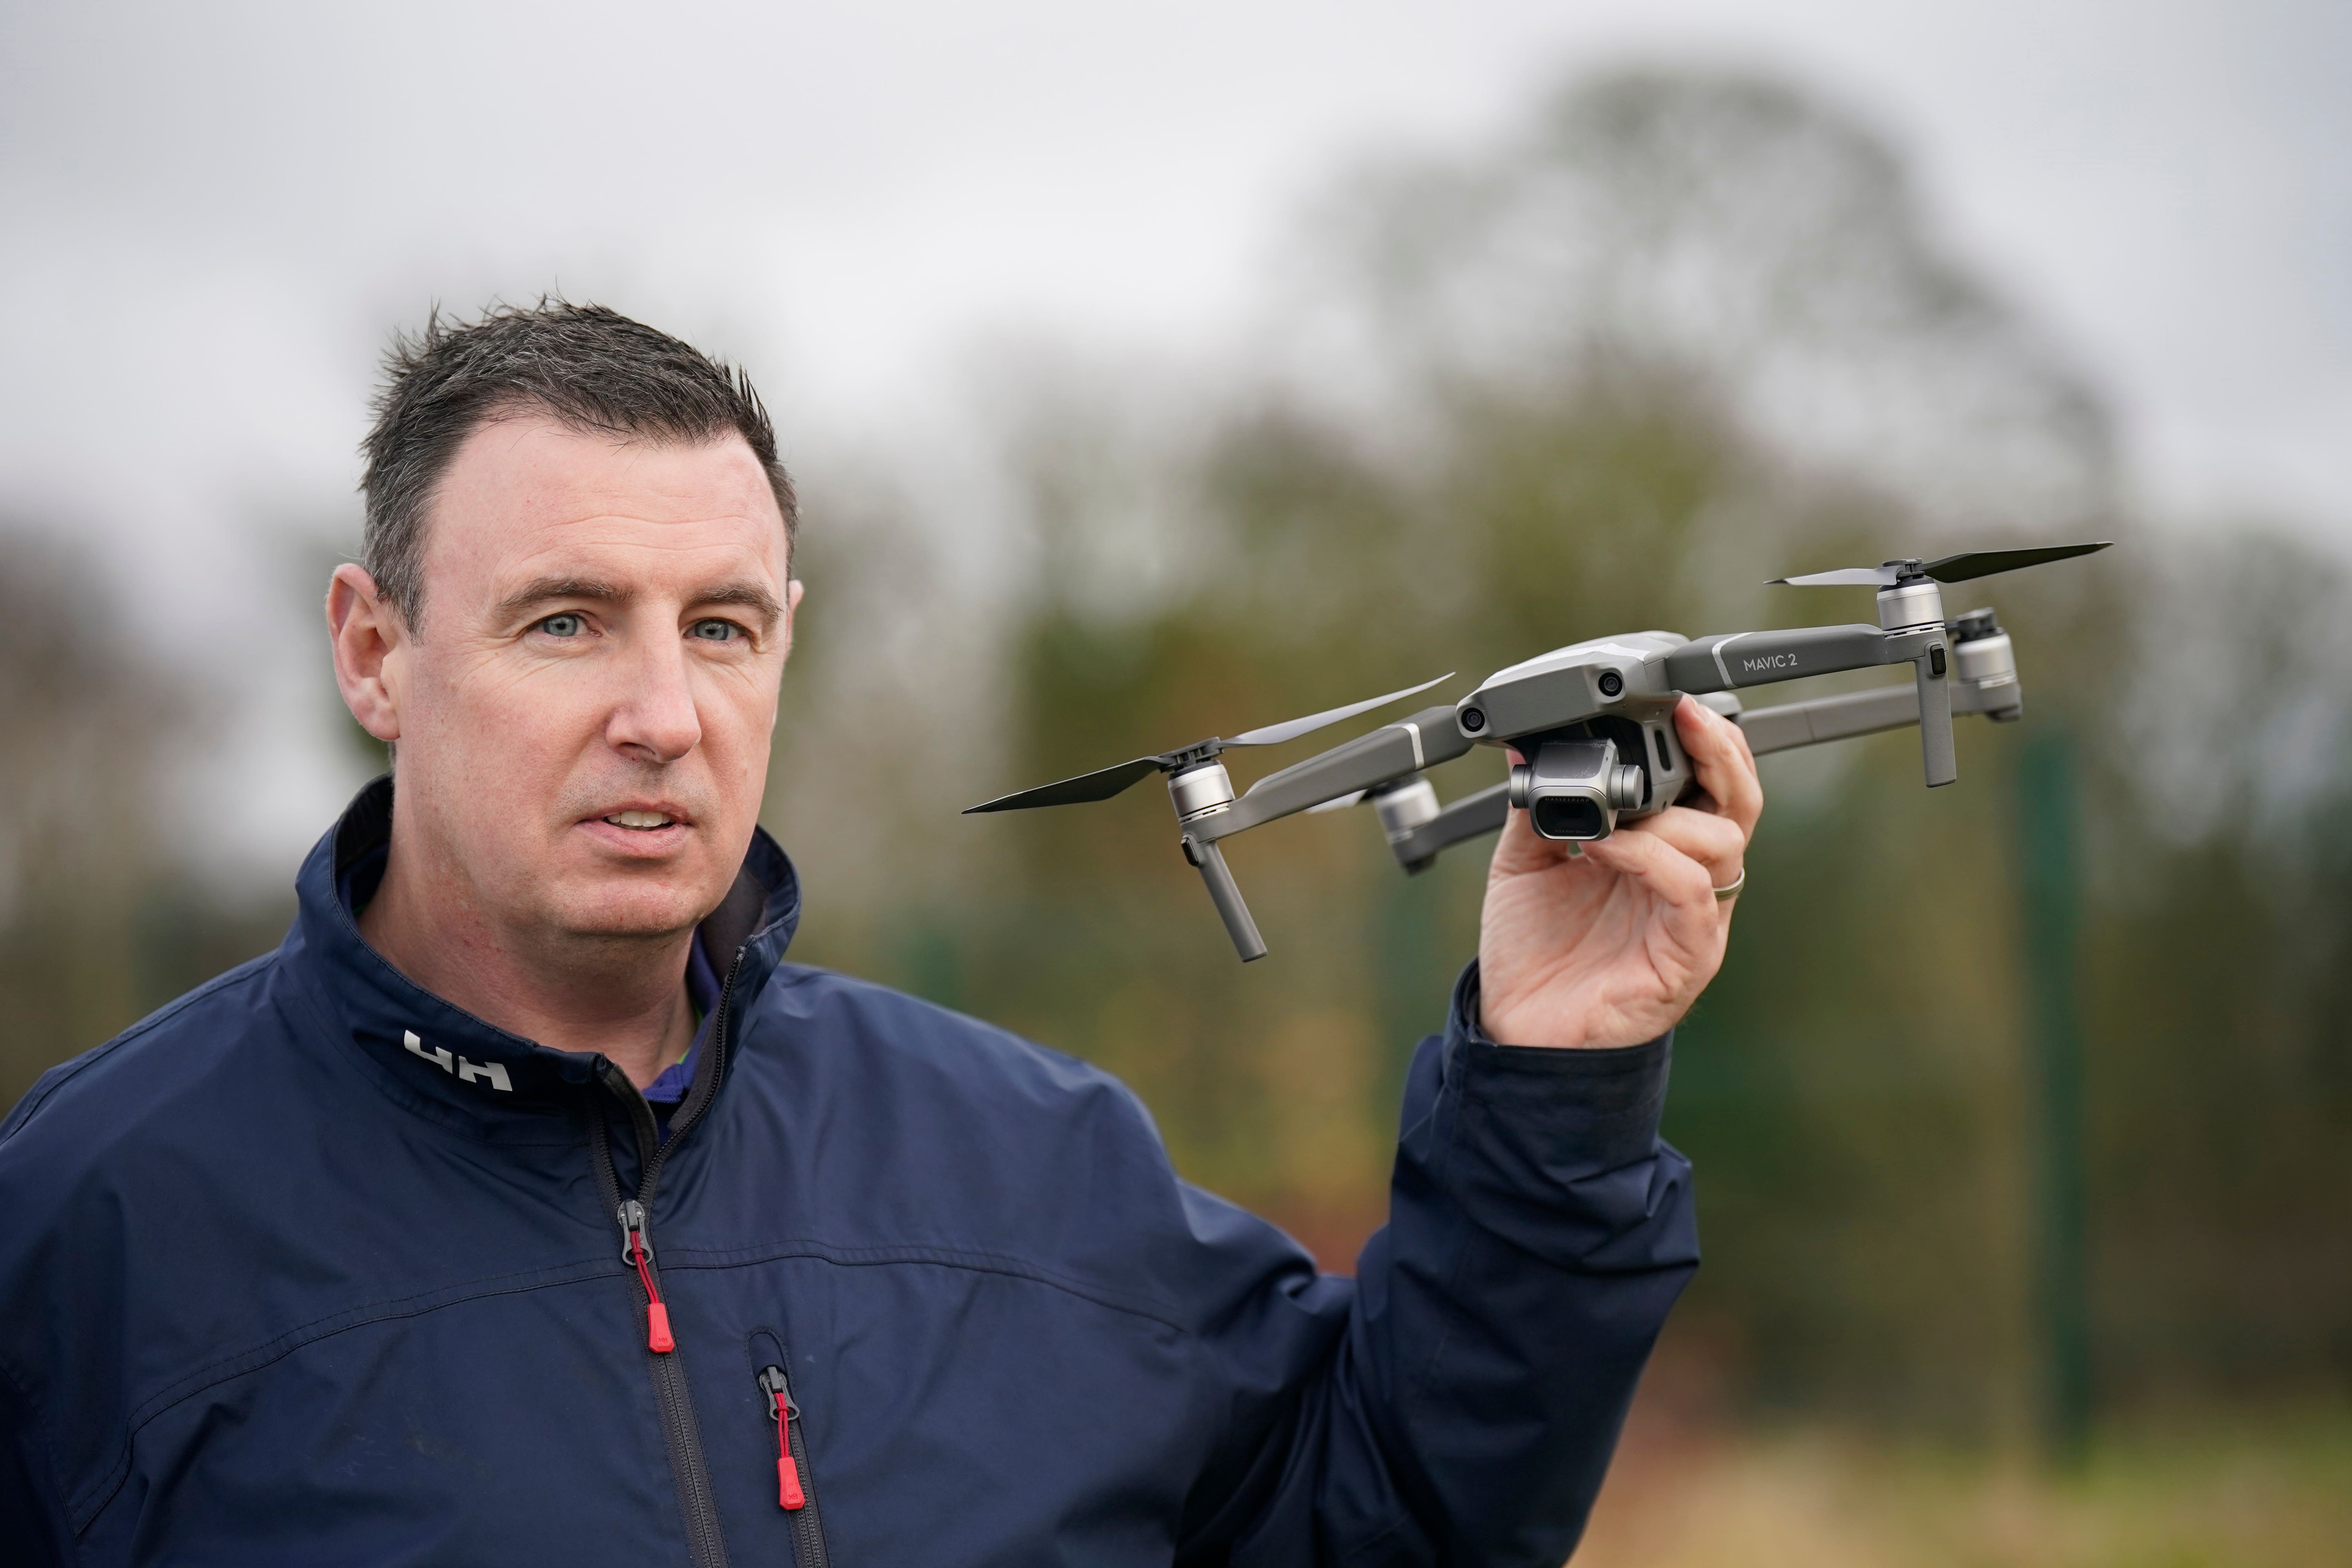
[{"left": 967, "top": 541, "right": 2112, "bottom": 964}]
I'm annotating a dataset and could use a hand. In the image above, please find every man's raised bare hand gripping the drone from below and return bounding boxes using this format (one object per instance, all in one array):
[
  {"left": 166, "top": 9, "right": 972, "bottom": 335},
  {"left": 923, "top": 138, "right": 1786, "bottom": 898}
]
[{"left": 1479, "top": 698, "right": 1764, "bottom": 1046}]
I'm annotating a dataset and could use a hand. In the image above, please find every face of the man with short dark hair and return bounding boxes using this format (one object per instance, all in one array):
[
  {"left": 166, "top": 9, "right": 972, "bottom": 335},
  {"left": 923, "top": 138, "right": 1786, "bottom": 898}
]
[{"left": 362, "top": 416, "right": 800, "bottom": 943}]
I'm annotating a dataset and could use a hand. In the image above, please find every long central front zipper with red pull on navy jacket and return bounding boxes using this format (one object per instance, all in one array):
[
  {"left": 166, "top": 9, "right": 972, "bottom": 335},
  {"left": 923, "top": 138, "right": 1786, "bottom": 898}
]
[{"left": 588, "top": 943, "right": 750, "bottom": 1568}]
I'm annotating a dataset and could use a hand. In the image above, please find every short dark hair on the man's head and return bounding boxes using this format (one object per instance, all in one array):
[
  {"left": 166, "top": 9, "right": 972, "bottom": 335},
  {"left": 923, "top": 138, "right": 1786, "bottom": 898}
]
[{"left": 360, "top": 299, "right": 800, "bottom": 630}]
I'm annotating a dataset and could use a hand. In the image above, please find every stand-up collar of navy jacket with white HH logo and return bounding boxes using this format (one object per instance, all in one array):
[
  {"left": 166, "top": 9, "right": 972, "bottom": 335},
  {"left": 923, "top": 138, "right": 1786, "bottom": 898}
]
[{"left": 289, "top": 776, "right": 800, "bottom": 1126}]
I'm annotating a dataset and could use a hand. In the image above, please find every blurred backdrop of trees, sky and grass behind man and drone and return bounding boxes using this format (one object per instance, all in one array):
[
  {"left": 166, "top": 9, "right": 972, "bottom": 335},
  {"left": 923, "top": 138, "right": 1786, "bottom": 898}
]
[{"left": 0, "top": 0, "right": 2352, "bottom": 1568}]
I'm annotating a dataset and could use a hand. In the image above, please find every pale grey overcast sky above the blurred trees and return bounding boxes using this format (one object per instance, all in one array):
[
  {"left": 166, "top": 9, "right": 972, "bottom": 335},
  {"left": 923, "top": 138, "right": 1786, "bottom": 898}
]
[{"left": 0, "top": 0, "right": 2352, "bottom": 879}]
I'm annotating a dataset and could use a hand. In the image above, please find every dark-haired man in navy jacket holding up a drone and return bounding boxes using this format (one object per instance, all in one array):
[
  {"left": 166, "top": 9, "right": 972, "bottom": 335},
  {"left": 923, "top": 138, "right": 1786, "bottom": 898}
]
[{"left": 0, "top": 303, "right": 1762, "bottom": 1568}]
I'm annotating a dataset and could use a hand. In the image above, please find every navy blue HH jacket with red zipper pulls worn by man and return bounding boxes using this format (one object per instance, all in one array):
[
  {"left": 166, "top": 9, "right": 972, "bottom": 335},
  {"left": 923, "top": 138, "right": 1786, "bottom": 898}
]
[{"left": 0, "top": 780, "right": 1696, "bottom": 1568}]
